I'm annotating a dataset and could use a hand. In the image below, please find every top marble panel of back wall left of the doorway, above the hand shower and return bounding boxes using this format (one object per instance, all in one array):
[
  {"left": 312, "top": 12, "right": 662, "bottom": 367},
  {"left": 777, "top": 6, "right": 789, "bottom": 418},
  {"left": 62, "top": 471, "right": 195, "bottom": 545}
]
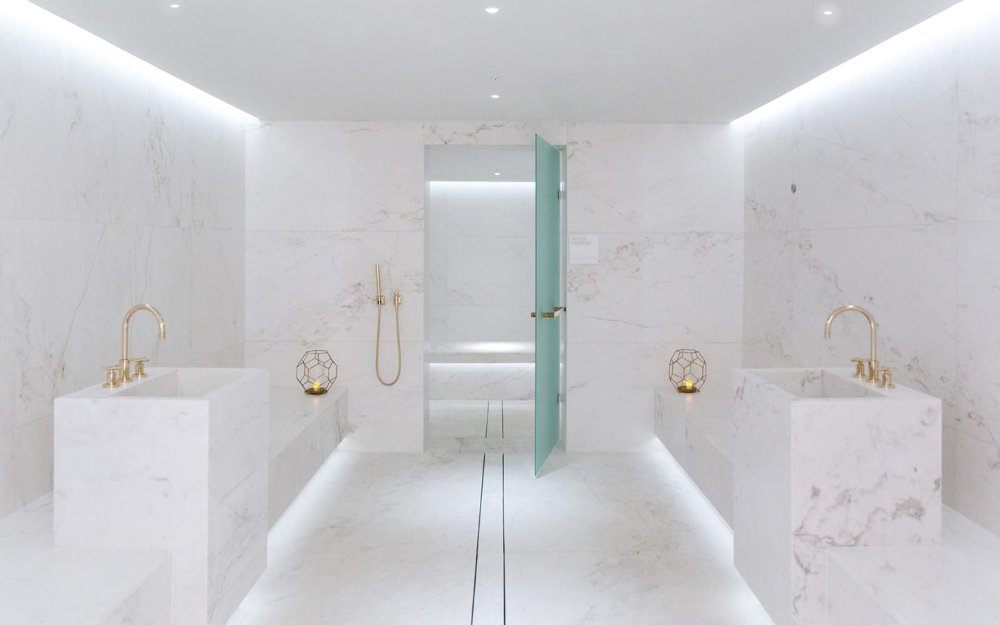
[{"left": 247, "top": 122, "right": 424, "bottom": 232}]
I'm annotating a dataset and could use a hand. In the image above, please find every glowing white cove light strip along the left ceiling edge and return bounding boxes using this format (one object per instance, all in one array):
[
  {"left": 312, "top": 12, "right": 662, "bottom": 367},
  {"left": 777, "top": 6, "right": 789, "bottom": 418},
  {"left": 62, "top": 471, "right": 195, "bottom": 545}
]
[{"left": 0, "top": 0, "right": 259, "bottom": 123}]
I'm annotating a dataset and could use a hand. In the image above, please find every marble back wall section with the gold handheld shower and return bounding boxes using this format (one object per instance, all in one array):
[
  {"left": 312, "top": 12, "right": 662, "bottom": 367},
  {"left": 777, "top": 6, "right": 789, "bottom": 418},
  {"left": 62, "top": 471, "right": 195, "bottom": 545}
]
[{"left": 246, "top": 122, "right": 424, "bottom": 451}]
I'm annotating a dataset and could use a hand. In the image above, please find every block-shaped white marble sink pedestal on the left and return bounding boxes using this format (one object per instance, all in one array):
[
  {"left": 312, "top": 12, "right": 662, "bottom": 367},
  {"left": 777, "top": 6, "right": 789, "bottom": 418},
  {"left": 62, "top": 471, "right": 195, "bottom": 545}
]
[{"left": 53, "top": 369, "right": 268, "bottom": 625}]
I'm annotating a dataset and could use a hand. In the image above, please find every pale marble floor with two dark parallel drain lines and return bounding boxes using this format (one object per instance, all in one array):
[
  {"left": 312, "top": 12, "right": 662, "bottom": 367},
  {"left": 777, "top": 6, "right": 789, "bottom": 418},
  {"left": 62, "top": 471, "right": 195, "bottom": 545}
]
[{"left": 230, "top": 401, "right": 771, "bottom": 625}]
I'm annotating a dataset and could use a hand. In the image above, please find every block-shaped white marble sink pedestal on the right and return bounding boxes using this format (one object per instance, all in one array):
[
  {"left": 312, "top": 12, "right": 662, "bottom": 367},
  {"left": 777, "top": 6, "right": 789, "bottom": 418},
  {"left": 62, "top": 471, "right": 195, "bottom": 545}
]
[{"left": 733, "top": 369, "right": 941, "bottom": 625}]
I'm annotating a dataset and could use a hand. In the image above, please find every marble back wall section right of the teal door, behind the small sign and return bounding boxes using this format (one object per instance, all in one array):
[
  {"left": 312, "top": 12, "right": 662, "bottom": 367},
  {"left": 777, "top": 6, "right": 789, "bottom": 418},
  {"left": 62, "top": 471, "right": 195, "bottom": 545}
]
[{"left": 567, "top": 124, "right": 743, "bottom": 450}]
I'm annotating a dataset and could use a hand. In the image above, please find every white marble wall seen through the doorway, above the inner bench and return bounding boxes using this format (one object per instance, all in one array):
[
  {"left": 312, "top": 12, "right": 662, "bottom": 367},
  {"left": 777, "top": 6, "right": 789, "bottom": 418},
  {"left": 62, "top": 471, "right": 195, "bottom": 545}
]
[{"left": 427, "top": 182, "right": 535, "bottom": 344}]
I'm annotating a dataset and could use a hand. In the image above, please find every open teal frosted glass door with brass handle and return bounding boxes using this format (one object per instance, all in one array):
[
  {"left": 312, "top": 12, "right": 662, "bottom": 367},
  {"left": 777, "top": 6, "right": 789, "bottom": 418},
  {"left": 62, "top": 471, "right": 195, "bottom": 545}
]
[{"left": 535, "top": 135, "right": 565, "bottom": 476}]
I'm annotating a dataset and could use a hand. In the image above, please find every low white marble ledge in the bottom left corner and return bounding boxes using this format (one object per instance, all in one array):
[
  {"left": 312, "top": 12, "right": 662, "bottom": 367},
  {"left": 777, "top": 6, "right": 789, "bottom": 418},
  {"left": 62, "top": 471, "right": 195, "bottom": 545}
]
[{"left": 0, "top": 495, "right": 171, "bottom": 625}]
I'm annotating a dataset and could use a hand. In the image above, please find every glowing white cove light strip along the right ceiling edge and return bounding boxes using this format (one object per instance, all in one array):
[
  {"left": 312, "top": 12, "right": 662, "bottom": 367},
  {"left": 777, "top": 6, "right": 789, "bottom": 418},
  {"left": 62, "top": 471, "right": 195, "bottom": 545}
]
[{"left": 732, "top": 0, "right": 1000, "bottom": 126}]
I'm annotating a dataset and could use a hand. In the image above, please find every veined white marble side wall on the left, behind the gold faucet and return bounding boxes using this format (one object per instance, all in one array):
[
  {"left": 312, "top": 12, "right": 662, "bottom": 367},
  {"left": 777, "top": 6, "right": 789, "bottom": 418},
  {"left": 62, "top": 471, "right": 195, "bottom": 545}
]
[{"left": 0, "top": 2, "right": 248, "bottom": 515}]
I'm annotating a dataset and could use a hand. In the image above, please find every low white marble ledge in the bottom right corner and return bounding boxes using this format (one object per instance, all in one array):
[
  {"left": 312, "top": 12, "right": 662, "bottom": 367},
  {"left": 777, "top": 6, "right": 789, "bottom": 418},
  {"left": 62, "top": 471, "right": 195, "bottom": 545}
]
[{"left": 827, "top": 506, "right": 1000, "bottom": 625}]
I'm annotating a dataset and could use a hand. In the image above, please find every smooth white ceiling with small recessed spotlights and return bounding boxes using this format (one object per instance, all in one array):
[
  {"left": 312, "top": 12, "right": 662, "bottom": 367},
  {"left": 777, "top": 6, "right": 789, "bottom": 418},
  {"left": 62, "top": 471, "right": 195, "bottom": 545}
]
[{"left": 34, "top": 0, "right": 957, "bottom": 122}]
